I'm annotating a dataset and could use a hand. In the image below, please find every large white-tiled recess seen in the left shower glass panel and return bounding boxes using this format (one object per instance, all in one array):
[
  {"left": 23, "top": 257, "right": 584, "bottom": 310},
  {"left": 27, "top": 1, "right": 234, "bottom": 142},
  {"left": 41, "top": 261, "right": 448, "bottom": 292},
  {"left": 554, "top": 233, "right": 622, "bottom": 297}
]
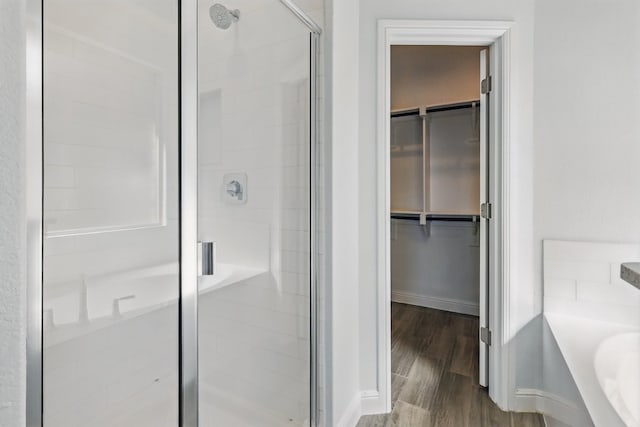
[{"left": 44, "top": 28, "right": 170, "bottom": 237}]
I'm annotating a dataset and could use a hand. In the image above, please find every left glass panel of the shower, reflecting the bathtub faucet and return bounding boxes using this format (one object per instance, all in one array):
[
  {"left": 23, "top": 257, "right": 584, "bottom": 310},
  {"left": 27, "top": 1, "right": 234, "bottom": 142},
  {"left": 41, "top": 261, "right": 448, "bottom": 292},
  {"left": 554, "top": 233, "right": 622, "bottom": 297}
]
[{"left": 43, "top": 0, "right": 179, "bottom": 427}]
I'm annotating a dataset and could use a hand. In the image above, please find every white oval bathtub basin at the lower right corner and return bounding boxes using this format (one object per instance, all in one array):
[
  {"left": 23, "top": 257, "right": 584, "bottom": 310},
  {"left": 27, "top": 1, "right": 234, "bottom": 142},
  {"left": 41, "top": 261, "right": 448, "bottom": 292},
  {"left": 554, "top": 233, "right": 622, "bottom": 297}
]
[{"left": 594, "top": 332, "right": 640, "bottom": 427}]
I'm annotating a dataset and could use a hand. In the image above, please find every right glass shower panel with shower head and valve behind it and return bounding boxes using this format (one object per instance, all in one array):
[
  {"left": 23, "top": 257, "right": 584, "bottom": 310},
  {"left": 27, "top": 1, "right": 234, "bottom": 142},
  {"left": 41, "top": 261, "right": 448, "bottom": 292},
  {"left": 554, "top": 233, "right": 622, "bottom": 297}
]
[{"left": 198, "top": 0, "right": 310, "bottom": 427}]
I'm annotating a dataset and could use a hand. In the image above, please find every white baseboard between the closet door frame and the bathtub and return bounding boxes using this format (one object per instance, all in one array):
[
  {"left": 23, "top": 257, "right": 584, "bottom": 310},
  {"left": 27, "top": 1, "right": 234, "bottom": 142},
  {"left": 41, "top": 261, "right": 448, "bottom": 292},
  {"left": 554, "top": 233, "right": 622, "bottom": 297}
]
[{"left": 512, "top": 388, "right": 593, "bottom": 427}]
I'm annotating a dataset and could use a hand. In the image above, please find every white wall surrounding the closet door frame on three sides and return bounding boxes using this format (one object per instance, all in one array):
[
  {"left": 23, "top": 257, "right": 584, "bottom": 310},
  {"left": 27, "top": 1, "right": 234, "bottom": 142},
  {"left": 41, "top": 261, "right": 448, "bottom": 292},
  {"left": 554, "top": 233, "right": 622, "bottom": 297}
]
[{"left": 358, "top": 0, "right": 540, "bottom": 404}]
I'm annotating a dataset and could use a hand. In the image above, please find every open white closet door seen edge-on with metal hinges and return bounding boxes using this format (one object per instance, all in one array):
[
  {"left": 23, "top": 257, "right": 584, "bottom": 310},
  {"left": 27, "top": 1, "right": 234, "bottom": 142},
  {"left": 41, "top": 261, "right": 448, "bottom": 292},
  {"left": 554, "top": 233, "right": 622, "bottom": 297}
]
[{"left": 478, "top": 49, "right": 491, "bottom": 387}]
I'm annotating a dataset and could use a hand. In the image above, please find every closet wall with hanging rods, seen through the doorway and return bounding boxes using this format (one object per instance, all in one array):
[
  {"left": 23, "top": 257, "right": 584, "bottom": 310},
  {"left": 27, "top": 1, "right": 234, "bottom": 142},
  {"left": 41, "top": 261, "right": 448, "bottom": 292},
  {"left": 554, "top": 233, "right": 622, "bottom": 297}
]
[{"left": 391, "top": 46, "right": 482, "bottom": 314}]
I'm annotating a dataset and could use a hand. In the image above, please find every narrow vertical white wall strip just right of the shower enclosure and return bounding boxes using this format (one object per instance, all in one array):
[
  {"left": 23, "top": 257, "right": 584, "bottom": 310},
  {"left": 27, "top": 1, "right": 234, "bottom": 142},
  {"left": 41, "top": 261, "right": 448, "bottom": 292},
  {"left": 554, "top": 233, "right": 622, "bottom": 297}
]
[{"left": 325, "top": 1, "right": 362, "bottom": 426}]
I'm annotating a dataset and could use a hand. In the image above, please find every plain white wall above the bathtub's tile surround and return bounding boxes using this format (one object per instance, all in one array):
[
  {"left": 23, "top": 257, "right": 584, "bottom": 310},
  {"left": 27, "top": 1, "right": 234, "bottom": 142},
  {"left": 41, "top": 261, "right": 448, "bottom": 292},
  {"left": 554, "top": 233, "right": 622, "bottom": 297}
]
[{"left": 534, "top": 0, "right": 640, "bottom": 300}]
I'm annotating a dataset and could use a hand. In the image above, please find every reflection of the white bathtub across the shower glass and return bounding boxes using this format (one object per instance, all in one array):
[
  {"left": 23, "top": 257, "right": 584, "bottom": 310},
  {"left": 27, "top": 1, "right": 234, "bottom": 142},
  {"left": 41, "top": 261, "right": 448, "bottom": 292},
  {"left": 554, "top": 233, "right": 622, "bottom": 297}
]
[{"left": 43, "top": 263, "right": 267, "bottom": 347}]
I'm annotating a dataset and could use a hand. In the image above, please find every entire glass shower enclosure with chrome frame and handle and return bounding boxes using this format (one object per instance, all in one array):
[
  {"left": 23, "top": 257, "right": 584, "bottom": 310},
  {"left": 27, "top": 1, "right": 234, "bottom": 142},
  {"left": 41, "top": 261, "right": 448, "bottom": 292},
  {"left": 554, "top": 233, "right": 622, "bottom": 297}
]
[{"left": 34, "top": 0, "right": 322, "bottom": 427}]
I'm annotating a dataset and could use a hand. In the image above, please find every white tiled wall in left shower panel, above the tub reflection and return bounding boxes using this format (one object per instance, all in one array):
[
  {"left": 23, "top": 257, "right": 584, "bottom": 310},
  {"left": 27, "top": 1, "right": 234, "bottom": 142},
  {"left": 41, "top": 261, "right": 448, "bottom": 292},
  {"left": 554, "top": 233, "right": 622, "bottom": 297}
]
[{"left": 44, "top": 0, "right": 178, "bottom": 286}]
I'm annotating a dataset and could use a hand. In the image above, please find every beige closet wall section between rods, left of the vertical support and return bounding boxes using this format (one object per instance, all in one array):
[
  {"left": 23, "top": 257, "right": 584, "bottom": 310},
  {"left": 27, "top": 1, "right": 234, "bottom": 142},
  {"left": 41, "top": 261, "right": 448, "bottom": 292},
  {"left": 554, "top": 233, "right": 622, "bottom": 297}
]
[{"left": 391, "top": 114, "right": 424, "bottom": 212}]
